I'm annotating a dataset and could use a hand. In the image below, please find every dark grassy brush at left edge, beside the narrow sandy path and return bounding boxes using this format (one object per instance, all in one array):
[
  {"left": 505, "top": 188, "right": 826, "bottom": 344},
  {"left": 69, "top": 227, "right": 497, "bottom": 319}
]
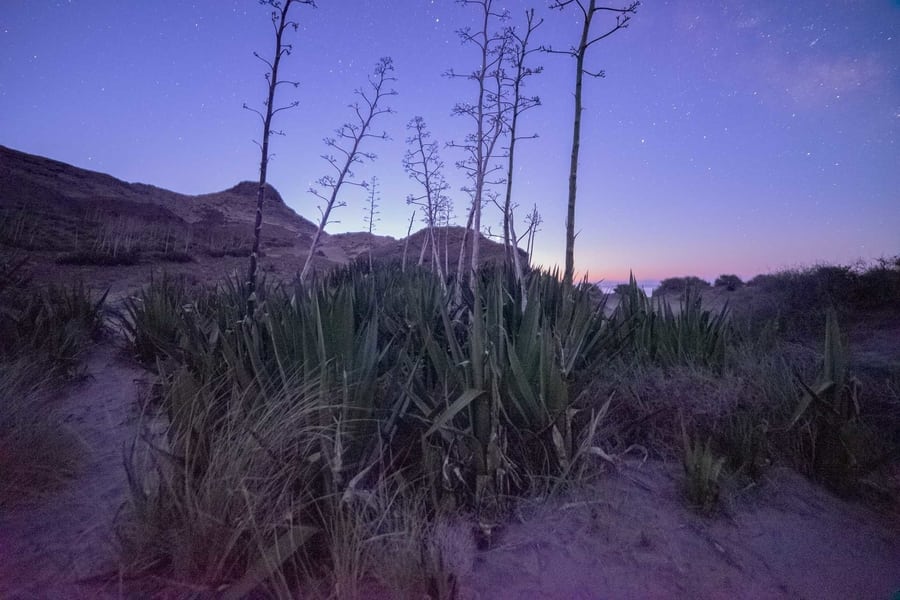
[{"left": 0, "top": 256, "right": 103, "bottom": 505}]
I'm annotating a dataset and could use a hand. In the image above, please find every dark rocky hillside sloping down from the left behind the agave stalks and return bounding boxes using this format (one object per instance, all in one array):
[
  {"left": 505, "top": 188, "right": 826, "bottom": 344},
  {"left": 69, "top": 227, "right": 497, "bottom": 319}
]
[{"left": 0, "top": 146, "right": 520, "bottom": 296}]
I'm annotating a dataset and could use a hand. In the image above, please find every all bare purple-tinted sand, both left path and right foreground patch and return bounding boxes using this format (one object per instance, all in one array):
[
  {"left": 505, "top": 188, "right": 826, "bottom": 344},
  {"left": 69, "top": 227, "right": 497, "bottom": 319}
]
[{"left": 0, "top": 342, "right": 900, "bottom": 600}]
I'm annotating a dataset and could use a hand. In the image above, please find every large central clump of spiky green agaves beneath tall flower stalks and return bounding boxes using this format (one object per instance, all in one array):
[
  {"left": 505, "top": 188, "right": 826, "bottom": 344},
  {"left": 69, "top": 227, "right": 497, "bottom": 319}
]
[{"left": 119, "top": 266, "right": 636, "bottom": 591}]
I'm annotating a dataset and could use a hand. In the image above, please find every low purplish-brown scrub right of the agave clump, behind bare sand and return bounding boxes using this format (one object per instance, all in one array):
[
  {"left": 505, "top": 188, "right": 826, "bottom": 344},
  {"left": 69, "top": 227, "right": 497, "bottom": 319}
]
[{"left": 582, "top": 314, "right": 816, "bottom": 480}]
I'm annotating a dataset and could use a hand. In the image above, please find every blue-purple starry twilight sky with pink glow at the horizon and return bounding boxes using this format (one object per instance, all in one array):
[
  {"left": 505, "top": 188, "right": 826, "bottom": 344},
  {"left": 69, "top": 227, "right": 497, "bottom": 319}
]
[{"left": 0, "top": 0, "right": 900, "bottom": 280}]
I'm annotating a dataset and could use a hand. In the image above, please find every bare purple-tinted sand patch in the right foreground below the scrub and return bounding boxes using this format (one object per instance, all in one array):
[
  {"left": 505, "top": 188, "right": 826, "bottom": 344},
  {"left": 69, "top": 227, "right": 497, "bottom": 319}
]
[{"left": 463, "top": 463, "right": 900, "bottom": 600}]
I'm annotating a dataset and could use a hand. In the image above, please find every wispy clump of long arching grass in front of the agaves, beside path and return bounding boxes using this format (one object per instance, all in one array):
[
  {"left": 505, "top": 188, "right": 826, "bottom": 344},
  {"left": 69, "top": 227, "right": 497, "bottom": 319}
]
[{"left": 119, "top": 371, "right": 324, "bottom": 597}]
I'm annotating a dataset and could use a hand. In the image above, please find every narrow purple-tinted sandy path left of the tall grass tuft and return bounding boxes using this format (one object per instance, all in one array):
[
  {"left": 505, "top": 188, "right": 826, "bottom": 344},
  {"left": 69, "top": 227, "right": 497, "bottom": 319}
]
[{"left": 0, "top": 341, "right": 148, "bottom": 598}]
